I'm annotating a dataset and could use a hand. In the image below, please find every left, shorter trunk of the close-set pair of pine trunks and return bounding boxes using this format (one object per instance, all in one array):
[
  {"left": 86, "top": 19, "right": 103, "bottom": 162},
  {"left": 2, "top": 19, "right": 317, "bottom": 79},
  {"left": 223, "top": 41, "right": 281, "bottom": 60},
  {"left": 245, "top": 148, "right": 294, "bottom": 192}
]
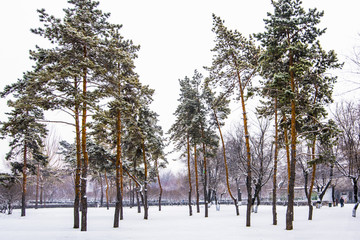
[{"left": 74, "top": 79, "right": 81, "bottom": 228}]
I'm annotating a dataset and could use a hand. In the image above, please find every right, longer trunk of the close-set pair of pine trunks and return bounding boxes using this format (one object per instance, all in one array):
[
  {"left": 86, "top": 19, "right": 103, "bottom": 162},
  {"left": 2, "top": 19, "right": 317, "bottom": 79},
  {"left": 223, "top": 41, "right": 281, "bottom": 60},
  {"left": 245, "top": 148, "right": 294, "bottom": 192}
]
[{"left": 81, "top": 46, "right": 89, "bottom": 231}]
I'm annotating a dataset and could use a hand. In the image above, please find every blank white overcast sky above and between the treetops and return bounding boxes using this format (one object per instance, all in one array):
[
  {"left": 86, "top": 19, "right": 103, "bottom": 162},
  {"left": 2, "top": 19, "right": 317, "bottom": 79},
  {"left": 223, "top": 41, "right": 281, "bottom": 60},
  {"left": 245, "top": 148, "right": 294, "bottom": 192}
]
[{"left": 0, "top": 0, "right": 360, "bottom": 172}]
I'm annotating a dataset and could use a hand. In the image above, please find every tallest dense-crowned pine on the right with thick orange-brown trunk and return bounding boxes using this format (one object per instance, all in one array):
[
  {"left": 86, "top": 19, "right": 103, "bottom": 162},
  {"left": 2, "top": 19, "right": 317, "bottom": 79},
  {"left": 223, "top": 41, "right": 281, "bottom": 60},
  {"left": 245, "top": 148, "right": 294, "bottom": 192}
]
[{"left": 257, "top": 0, "right": 336, "bottom": 230}]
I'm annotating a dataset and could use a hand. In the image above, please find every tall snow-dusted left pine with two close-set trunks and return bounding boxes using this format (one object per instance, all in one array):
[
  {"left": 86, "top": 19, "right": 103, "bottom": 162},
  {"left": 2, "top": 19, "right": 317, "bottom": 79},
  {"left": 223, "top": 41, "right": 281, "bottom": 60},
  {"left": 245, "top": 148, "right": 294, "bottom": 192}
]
[{"left": 31, "top": 0, "right": 120, "bottom": 231}]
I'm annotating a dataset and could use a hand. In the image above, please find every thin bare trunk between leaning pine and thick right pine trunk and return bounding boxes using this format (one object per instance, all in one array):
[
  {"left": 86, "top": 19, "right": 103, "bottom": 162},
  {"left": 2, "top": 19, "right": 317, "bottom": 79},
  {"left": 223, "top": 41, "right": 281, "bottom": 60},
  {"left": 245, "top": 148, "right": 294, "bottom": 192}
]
[{"left": 272, "top": 96, "right": 279, "bottom": 225}]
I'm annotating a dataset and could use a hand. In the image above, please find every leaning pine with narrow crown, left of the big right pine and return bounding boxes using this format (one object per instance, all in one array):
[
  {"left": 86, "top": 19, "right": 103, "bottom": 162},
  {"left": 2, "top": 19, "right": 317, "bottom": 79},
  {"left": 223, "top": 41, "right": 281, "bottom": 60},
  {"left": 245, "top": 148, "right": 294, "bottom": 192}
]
[{"left": 208, "top": 15, "right": 260, "bottom": 227}]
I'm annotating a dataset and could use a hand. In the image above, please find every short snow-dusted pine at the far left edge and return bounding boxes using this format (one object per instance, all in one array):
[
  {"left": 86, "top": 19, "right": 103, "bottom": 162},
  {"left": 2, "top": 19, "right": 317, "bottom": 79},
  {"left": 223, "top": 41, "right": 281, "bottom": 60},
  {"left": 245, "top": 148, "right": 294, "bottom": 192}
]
[{"left": 1, "top": 72, "right": 47, "bottom": 216}]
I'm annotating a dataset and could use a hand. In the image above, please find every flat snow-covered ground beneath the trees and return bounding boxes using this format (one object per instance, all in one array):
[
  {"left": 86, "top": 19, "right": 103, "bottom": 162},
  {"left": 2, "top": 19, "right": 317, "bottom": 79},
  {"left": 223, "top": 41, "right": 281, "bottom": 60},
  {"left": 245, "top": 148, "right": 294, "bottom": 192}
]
[{"left": 0, "top": 205, "right": 360, "bottom": 240}]
